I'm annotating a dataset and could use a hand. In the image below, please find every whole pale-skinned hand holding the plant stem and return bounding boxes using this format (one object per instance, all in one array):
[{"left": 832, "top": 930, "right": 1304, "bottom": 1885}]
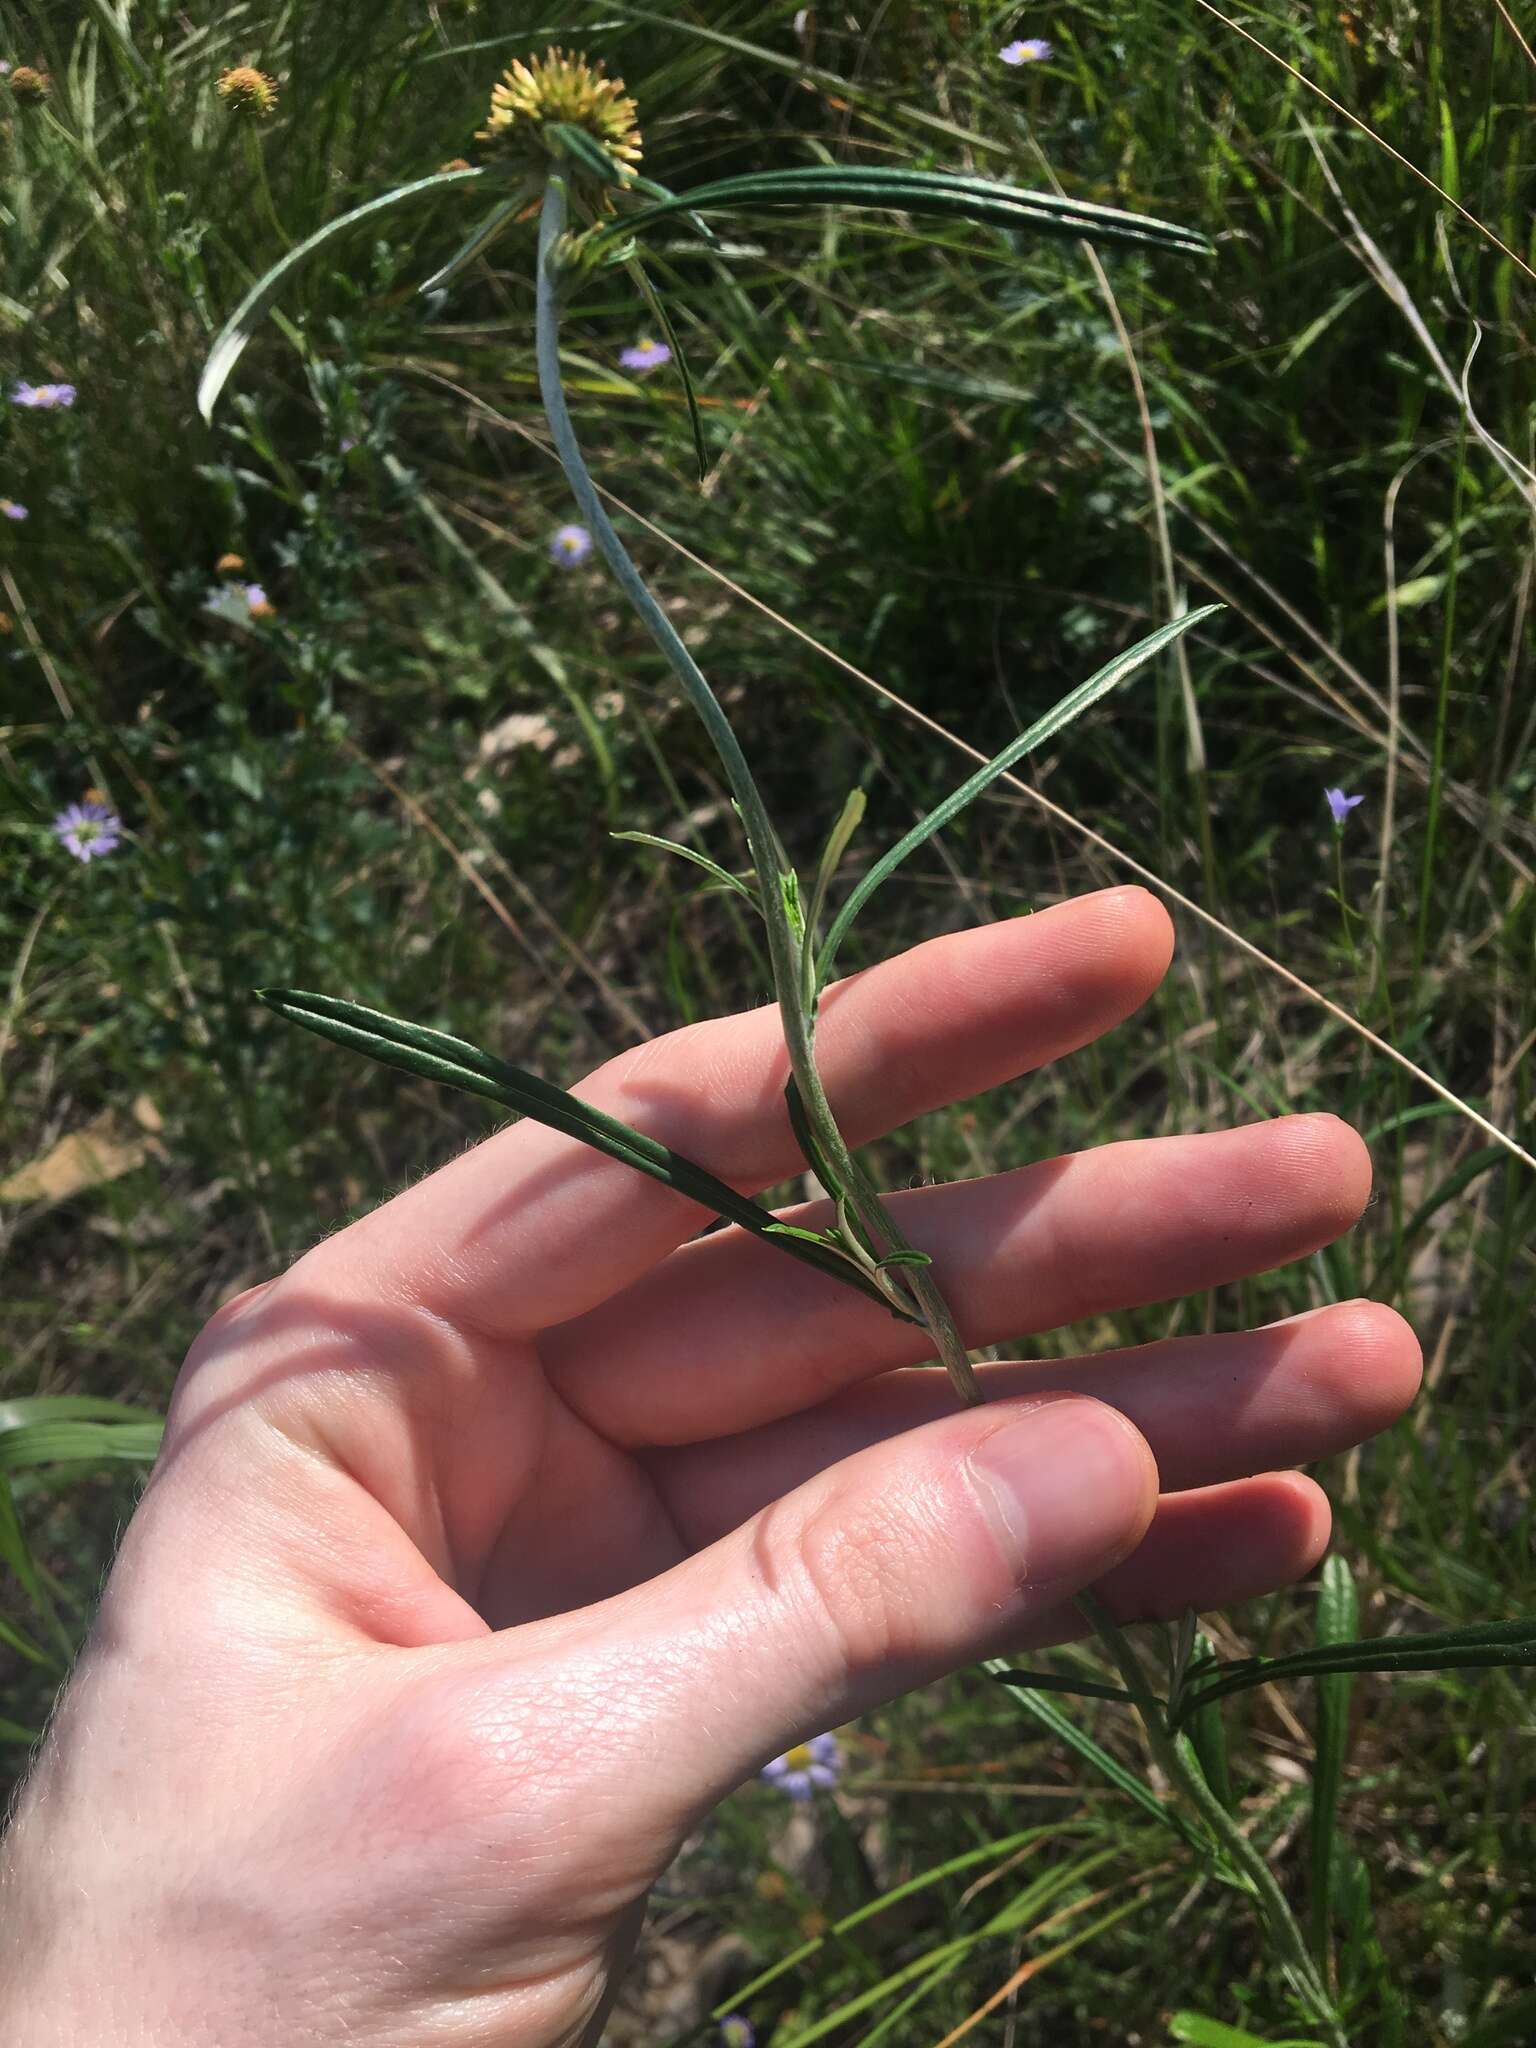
[{"left": 0, "top": 889, "right": 1419, "bottom": 2048}]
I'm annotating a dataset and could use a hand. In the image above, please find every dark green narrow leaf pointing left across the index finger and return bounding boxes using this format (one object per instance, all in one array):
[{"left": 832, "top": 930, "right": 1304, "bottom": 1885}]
[{"left": 259, "top": 989, "right": 913, "bottom": 1310}]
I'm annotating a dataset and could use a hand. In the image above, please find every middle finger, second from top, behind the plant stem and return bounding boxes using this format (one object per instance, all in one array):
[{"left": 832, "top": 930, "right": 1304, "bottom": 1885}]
[{"left": 541, "top": 1116, "right": 1370, "bottom": 1448}]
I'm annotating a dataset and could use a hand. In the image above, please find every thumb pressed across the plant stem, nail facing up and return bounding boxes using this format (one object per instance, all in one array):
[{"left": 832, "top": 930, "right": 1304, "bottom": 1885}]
[{"left": 588, "top": 1395, "right": 1157, "bottom": 1827}]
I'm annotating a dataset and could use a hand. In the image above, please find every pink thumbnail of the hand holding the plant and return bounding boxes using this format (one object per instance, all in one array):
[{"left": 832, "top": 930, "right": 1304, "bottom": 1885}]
[{"left": 969, "top": 1397, "right": 1157, "bottom": 1585}]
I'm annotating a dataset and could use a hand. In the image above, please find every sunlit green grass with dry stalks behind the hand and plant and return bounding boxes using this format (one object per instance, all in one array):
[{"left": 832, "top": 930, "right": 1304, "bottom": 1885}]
[{"left": 0, "top": 0, "right": 1536, "bottom": 2048}]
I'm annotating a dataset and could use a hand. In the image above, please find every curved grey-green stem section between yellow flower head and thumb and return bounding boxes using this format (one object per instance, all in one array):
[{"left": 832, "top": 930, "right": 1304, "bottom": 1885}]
[{"left": 535, "top": 170, "right": 981, "bottom": 1403}]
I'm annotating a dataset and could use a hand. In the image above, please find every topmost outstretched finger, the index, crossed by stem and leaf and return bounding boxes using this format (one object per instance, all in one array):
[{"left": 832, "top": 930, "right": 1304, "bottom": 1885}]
[{"left": 295, "top": 889, "right": 1174, "bottom": 1339}]
